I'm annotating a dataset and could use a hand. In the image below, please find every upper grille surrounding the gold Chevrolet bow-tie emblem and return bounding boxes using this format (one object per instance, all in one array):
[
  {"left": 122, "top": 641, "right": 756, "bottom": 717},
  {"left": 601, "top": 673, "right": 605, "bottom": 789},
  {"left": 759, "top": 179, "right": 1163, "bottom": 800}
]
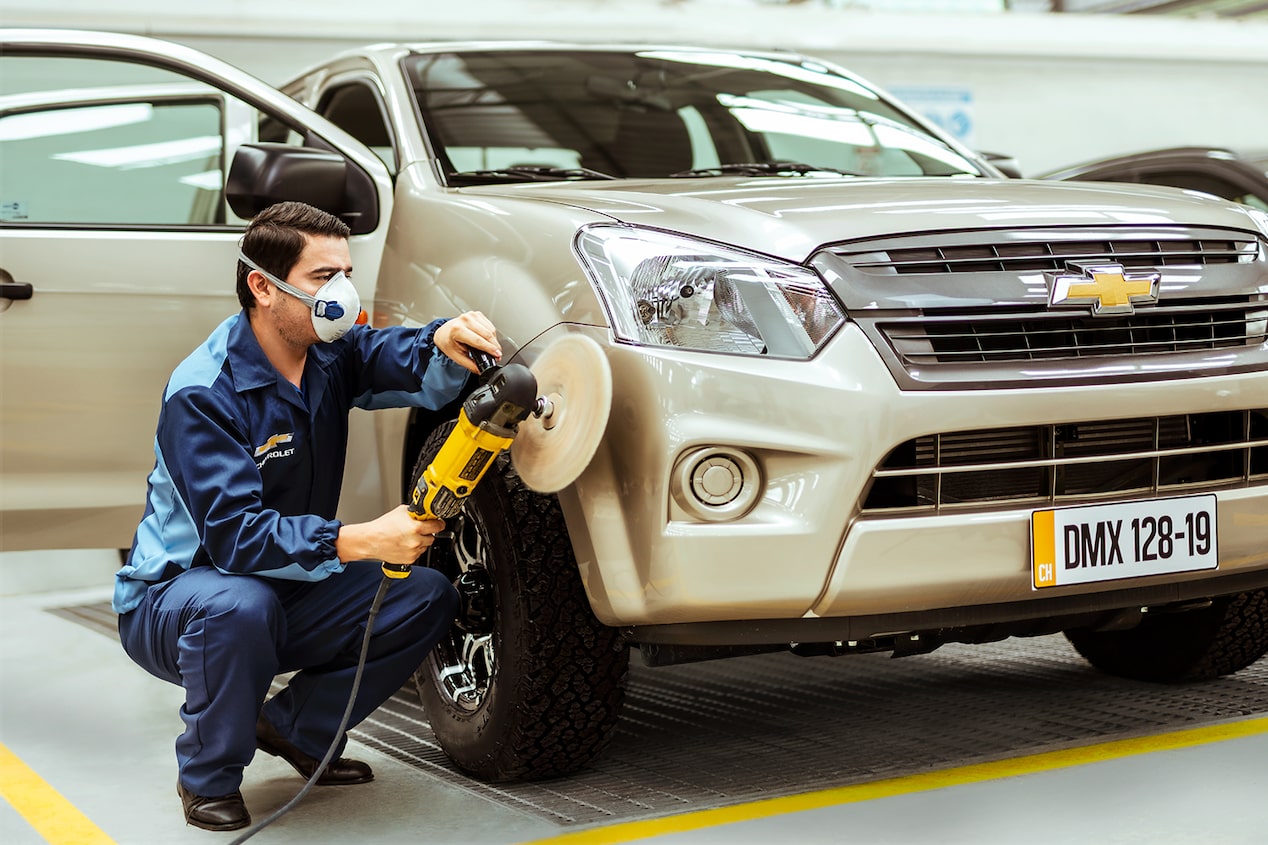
[{"left": 812, "top": 225, "right": 1268, "bottom": 390}]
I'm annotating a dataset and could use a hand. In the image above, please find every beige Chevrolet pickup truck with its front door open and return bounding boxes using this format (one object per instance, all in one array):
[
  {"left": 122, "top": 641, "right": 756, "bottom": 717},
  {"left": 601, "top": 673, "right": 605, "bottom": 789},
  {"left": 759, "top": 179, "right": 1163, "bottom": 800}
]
[{"left": 7, "top": 30, "right": 1268, "bottom": 780}]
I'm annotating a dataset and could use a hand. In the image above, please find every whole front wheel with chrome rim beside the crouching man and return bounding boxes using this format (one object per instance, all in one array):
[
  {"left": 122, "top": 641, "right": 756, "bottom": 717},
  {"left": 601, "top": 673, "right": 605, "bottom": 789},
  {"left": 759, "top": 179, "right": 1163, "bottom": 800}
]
[{"left": 412, "top": 423, "right": 629, "bottom": 782}]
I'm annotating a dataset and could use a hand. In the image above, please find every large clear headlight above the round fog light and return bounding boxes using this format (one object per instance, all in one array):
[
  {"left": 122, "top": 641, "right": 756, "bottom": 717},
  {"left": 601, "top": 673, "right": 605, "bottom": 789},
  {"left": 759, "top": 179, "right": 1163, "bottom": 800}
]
[{"left": 577, "top": 226, "right": 846, "bottom": 358}]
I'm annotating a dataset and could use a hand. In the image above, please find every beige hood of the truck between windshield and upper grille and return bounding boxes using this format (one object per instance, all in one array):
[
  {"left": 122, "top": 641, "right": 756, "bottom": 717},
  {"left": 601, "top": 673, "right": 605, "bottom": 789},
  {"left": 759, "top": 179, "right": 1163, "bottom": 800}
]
[{"left": 463, "top": 176, "right": 1255, "bottom": 261}]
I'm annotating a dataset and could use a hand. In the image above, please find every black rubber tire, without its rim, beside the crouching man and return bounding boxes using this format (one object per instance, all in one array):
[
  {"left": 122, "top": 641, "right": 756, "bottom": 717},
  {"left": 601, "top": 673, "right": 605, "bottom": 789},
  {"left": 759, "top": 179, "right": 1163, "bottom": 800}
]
[{"left": 413, "top": 425, "right": 629, "bottom": 783}]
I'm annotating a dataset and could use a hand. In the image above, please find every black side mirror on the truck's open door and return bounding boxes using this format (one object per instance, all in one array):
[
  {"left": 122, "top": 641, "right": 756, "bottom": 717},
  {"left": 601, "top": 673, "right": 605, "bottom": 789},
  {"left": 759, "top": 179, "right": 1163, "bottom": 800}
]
[{"left": 224, "top": 143, "right": 378, "bottom": 235}]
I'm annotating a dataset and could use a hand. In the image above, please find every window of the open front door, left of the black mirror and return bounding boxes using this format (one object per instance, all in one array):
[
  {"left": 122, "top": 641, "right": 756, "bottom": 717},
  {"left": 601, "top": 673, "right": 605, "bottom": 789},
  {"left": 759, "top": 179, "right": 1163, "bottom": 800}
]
[{"left": 0, "top": 55, "right": 332, "bottom": 228}]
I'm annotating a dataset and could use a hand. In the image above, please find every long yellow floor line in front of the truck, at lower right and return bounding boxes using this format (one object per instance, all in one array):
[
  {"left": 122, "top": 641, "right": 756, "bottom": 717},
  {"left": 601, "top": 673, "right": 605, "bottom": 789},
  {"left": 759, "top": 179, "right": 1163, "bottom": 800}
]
[{"left": 525, "top": 717, "right": 1268, "bottom": 845}]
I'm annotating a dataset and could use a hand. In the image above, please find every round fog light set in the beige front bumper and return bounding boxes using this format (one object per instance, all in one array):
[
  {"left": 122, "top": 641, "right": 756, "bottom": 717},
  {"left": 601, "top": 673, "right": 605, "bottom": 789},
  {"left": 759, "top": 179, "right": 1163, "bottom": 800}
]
[{"left": 670, "top": 447, "right": 762, "bottom": 521}]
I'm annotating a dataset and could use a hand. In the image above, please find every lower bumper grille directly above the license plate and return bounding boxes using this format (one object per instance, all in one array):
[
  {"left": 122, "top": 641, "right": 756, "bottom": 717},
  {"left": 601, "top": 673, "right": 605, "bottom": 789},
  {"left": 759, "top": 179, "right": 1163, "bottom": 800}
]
[{"left": 864, "top": 409, "right": 1268, "bottom": 515}]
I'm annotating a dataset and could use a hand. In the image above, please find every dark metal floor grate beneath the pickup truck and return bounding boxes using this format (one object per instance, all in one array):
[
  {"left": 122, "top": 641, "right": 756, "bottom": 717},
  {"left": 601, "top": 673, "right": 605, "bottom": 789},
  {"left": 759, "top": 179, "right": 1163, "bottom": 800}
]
[{"left": 55, "top": 605, "right": 1268, "bottom": 826}]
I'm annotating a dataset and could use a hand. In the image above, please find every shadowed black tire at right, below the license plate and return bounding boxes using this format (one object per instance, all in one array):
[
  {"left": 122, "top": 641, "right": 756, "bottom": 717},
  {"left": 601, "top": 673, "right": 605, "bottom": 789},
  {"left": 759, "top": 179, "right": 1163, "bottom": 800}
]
[{"left": 1065, "top": 590, "right": 1268, "bottom": 684}]
